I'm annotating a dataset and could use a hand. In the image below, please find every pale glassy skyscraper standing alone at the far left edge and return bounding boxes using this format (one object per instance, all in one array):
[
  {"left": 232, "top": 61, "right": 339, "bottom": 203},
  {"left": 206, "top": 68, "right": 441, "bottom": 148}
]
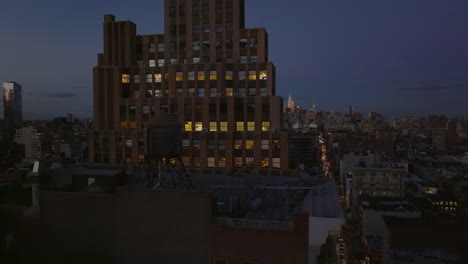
[{"left": 3, "top": 82, "right": 23, "bottom": 129}]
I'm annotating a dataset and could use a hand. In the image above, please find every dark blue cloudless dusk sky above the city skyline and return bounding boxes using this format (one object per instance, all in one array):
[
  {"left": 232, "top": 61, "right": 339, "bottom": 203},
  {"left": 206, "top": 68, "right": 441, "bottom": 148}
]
[{"left": 0, "top": 0, "right": 468, "bottom": 118}]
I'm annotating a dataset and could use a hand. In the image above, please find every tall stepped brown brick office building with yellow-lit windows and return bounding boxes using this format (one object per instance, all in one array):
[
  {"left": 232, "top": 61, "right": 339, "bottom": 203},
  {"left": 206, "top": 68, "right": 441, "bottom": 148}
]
[{"left": 90, "top": 0, "right": 289, "bottom": 175}]
